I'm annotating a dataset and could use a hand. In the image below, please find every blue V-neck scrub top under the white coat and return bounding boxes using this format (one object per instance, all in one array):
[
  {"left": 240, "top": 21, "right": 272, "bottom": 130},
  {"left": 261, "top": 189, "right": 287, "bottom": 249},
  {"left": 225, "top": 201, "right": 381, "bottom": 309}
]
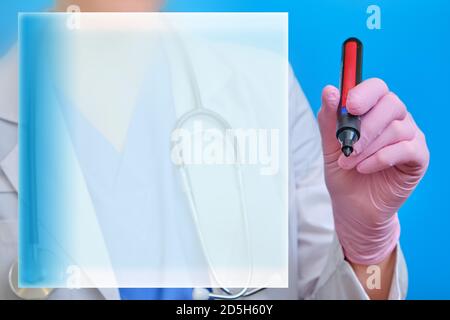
[{"left": 54, "top": 41, "right": 198, "bottom": 300}]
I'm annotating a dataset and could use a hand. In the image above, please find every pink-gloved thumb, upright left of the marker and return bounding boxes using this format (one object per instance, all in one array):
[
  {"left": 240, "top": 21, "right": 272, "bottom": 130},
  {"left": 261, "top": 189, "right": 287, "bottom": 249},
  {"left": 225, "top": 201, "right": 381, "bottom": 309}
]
[{"left": 317, "top": 85, "right": 340, "bottom": 160}]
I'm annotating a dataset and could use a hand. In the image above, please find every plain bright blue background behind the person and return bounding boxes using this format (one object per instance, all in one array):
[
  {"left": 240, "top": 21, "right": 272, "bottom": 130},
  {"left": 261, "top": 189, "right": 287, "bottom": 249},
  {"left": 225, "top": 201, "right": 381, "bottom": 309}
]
[{"left": 0, "top": 0, "right": 450, "bottom": 299}]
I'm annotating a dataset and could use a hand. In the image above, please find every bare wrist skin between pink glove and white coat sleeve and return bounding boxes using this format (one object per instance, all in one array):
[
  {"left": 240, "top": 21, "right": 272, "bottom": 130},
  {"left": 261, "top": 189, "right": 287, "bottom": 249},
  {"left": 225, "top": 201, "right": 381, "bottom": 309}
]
[{"left": 349, "top": 249, "right": 397, "bottom": 300}]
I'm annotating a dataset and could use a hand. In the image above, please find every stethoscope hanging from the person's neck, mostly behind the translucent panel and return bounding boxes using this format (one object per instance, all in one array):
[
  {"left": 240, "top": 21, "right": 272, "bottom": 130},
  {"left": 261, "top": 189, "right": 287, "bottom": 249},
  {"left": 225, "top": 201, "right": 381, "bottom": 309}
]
[{"left": 9, "top": 26, "right": 266, "bottom": 300}]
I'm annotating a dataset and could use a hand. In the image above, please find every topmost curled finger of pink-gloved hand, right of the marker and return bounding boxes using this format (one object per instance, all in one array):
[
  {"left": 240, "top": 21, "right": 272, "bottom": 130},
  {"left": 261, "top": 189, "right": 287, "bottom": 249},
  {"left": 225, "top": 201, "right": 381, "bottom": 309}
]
[{"left": 346, "top": 78, "right": 389, "bottom": 115}]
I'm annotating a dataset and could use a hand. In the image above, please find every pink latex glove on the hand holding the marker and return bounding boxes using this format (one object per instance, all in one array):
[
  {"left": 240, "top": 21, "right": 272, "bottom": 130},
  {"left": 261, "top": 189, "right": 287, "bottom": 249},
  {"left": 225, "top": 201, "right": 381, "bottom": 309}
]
[{"left": 318, "top": 78, "right": 429, "bottom": 265}]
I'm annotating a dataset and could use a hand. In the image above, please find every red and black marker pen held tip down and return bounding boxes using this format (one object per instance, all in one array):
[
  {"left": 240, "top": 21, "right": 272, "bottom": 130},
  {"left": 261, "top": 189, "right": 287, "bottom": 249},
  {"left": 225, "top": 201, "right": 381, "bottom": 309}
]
[{"left": 336, "top": 38, "right": 362, "bottom": 157}]
